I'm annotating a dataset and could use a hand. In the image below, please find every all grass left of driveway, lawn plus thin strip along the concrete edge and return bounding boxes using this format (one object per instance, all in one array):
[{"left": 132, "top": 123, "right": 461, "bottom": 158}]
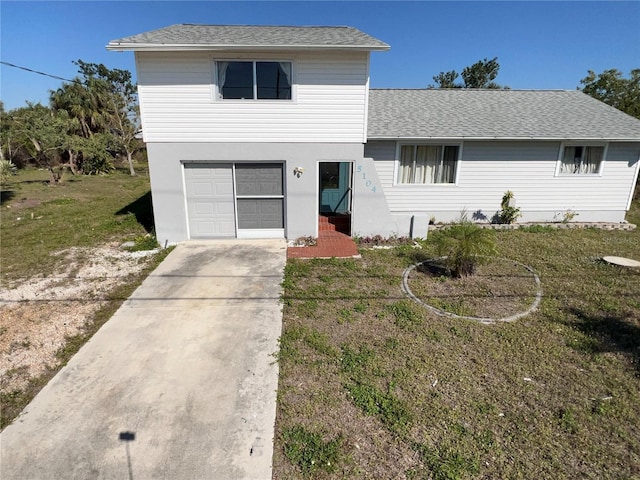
[{"left": 0, "top": 170, "right": 170, "bottom": 428}]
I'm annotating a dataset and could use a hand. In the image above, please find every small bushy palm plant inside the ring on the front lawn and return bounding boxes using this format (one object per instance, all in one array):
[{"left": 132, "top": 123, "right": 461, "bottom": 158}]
[{"left": 432, "top": 214, "right": 497, "bottom": 278}]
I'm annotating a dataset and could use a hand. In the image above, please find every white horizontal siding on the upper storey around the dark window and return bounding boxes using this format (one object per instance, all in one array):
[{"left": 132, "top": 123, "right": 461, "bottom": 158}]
[{"left": 136, "top": 52, "right": 369, "bottom": 143}]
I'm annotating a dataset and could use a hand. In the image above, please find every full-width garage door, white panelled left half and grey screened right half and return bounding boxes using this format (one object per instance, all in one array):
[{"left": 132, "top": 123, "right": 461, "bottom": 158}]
[{"left": 184, "top": 163, "right": 284, "bottom": 238}]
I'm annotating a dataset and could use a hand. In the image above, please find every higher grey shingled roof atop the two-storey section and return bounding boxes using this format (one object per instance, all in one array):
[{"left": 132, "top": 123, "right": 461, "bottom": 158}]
[{"left": 107, "top": 24, "right": 390, "bottom": 50}]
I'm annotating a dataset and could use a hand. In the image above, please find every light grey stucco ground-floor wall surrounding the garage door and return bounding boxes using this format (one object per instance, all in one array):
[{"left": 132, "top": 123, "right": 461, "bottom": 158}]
[{"left": 147, "top": 142, "right": 363, "bottom": 246}]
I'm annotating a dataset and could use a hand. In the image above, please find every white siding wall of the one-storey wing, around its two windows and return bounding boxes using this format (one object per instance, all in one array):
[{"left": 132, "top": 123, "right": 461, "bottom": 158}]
[{"left": 365, "top": 141, "right": 640, "bottom": 232}]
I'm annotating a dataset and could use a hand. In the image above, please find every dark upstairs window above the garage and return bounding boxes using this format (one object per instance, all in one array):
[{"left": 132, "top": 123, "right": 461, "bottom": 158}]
[{"left": 216, "top": 61, "right": 291, "bottom": 100}]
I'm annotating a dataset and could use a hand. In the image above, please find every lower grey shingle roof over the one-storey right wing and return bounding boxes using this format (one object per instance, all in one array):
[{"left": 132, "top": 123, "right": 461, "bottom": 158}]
[{"left": 367, "top": 89, "right": 640, "bottom": 141}]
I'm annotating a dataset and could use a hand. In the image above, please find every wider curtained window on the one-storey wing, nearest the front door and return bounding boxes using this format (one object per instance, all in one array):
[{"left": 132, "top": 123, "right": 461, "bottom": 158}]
[{"left": 398, "top": 145, "right": 460, "bottom": 183}]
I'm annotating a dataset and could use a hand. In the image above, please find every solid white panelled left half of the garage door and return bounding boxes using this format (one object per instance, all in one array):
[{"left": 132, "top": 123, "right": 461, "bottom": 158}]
[{"left": 184, "top": 163, "right": 236, "bottom": 238}]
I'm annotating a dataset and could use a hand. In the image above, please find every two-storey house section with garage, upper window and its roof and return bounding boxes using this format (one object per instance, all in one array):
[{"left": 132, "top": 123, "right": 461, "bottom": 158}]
[{"left": 107, "top": 25, "right": 389, "bottom": 244}]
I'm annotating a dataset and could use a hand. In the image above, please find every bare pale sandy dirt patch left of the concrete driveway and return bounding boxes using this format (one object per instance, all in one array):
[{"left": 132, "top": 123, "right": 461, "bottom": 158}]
[{"left": 0, "top": 244, "right": 158, "bottom": 393}]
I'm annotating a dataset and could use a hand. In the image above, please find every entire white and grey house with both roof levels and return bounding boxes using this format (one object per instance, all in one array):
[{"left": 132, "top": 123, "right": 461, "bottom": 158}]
[{"left": 107, "top": 25, "right": 640, "bottom": 244}]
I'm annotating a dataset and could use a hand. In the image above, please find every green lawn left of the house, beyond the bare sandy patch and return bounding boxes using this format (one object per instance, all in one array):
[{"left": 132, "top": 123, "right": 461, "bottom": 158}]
[{"left": 0, "top": 170, "right": 152, "bottom": 282}]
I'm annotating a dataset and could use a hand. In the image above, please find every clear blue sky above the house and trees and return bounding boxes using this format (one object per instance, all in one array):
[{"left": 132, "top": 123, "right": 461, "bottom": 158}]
[{"left": 0, "top": 0, "right": 640, "bottom": 110}]
